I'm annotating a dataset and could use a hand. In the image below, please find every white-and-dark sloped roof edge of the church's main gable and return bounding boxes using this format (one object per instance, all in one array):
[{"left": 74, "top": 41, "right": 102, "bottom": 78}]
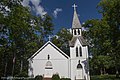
[{"left": 28, "top": 41, "right": 69, "bottom": 60}]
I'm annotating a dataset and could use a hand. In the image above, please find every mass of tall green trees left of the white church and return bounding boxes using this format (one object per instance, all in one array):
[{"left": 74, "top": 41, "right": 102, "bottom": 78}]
[{"left": 0, "top": 0, "right": 53, "bottom": 76}]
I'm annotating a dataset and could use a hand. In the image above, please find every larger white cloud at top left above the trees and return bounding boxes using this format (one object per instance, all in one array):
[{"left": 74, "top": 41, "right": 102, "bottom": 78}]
[{"left": 22, "top": 0, "right": 47, "bottom": 16}]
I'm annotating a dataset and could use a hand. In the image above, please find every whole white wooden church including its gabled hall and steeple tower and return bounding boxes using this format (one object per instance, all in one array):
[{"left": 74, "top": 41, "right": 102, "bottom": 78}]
[{"left": 28, "top": 5, "right": 90, "bottom": 80}]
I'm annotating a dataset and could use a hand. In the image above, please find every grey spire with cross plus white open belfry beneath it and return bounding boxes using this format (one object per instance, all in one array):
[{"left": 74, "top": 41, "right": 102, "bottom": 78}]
[{"left": 72, "top": 4, "right": 82, "bottom": 36}]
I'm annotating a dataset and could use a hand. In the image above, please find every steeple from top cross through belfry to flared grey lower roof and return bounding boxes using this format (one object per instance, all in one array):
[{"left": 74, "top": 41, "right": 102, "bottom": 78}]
[{"left": 70, "top": 4, "right": 87, "bottom": 47}]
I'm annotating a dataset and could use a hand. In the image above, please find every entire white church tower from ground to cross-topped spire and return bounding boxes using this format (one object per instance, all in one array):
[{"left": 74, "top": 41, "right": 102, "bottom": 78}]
[{"left": 69, "top": 4, "right": 90, "bottom": 80}]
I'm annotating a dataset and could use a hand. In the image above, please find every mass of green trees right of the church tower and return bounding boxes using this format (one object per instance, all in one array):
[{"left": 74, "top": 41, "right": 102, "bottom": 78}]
[{"left": 84, "top": 0, "right": 120, "bottom": 77}]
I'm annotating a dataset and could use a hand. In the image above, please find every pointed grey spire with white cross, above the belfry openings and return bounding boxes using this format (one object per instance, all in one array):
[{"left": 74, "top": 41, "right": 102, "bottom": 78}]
[{"left": 72, "top": 4, "right": 82, "bottom": 28}]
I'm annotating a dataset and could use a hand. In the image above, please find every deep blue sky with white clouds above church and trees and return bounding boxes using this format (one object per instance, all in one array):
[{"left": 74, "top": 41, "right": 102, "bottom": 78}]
[{"left": 23, "top": 0, "right": 101, "bottom": 33}]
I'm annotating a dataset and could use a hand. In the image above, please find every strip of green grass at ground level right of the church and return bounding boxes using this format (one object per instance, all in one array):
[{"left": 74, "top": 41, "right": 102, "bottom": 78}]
[{"left": 91, "top": 75, "right": 120, "bottom": 80}]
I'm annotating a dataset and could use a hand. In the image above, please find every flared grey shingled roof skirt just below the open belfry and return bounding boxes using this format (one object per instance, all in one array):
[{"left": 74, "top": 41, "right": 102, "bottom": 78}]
[{"left": 69, "top": 36, "right": 88, "bottom": 47}]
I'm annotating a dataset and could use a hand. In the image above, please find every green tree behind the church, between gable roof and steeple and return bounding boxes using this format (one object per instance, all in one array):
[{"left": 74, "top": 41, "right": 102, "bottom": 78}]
[{"left": 52, "top": 28, "right": 72, "bottom": 55}]
